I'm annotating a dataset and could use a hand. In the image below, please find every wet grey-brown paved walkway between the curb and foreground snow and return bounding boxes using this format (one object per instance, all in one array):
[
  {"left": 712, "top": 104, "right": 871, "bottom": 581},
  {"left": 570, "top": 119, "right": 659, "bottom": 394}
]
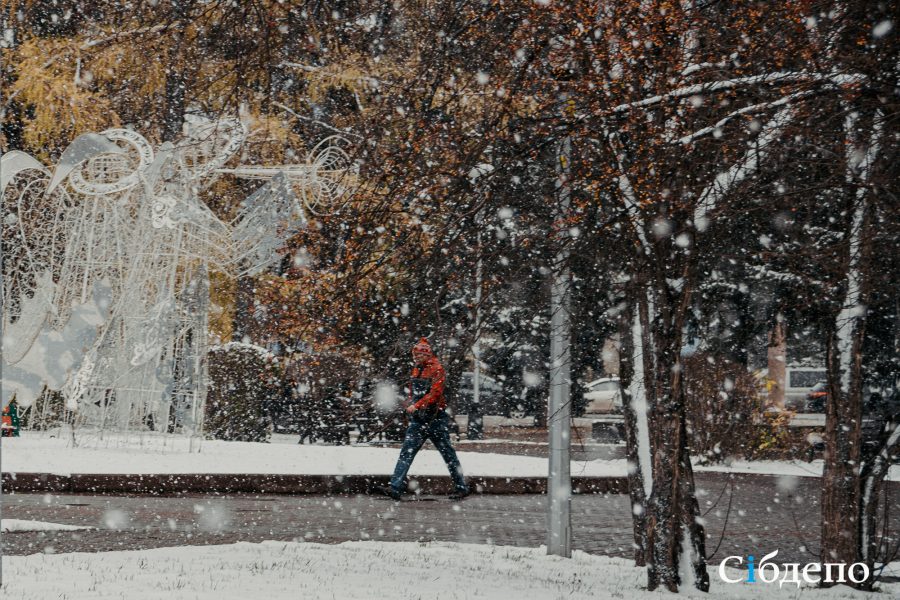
[{"left": 2, "top": 473, "right": 900, "bottom": 563}]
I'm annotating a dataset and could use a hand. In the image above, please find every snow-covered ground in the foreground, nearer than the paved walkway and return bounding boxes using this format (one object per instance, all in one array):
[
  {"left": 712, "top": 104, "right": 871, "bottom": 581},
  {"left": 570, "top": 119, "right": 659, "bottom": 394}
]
[{"left": 2, "top": 542, "right": 900, "bottom": 600}]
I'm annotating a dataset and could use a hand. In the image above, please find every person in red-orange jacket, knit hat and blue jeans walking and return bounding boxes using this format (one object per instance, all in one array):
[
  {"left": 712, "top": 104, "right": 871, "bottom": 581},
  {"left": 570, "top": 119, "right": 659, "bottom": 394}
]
[{"left": 378, "top": 338, "right": 469, "bottom": 500}]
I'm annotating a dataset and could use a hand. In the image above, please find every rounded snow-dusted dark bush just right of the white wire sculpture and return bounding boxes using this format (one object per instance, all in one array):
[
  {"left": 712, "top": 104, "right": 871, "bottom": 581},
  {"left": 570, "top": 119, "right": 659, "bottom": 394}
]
[{"left": 205, "top": 342, "right": 282, "bottom": 442}]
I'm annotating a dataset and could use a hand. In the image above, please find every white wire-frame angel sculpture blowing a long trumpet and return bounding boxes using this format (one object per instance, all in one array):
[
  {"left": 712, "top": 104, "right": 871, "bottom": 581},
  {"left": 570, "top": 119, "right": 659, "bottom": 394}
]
[{"left": 0, "top": 118, "right": 352, "bottom": 448}]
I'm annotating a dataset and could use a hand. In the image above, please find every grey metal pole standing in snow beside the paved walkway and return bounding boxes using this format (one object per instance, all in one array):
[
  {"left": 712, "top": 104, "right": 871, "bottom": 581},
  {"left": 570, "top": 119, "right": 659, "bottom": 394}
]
[{"left": 547, "top": 136, "right": 572, "bottom": 558}]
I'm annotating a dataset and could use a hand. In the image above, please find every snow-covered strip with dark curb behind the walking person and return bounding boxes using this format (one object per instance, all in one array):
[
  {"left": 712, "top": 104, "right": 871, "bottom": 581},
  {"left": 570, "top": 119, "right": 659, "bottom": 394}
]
[{"left": 2, "top": 432, "right": 900, "bottom": 494}]
